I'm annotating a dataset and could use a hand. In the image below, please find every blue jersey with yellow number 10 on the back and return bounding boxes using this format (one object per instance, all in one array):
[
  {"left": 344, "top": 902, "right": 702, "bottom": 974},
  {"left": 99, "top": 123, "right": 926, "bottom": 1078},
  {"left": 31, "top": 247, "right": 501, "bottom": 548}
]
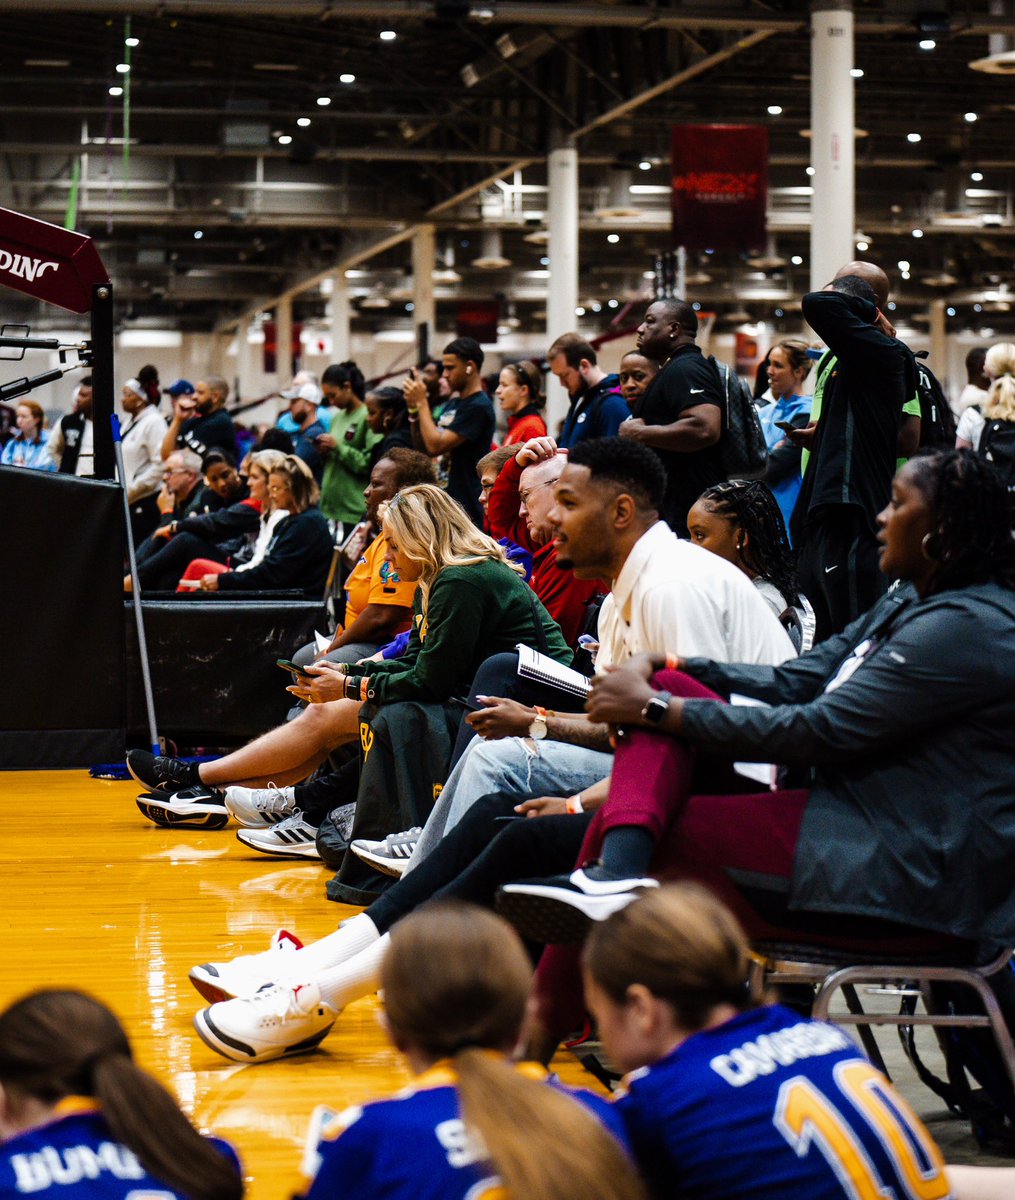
[{"left": 617, "top": 1007, "right": 949, "bottom": 1200}]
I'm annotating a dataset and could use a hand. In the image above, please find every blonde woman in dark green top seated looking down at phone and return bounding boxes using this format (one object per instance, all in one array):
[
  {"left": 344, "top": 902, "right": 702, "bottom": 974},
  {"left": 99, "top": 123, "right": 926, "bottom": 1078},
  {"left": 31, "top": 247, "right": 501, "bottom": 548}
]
[{"left": 127, "top": 474, "right": 571, "bottom": 856}]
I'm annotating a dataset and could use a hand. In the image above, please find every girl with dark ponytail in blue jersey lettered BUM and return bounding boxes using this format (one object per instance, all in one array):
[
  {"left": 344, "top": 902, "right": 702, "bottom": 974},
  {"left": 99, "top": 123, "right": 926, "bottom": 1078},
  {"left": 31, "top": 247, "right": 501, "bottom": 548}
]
[{"left": 0, "top": 991, "right": 244, "bottom": 1200}]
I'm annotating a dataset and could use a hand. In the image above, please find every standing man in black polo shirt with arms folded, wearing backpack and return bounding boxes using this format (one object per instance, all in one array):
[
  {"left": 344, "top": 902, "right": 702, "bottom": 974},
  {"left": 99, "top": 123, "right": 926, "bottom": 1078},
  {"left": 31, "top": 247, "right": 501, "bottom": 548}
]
[{"left": 619, "top": 300, "right": 726, "bottom": 538}]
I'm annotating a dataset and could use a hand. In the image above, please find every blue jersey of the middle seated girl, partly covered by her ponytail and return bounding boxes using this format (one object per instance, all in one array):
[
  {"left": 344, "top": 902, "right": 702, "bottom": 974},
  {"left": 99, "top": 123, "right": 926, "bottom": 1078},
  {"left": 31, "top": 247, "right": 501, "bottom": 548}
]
[{"left": 306, "top": 1063, "right": 627, "bottom": 1200}]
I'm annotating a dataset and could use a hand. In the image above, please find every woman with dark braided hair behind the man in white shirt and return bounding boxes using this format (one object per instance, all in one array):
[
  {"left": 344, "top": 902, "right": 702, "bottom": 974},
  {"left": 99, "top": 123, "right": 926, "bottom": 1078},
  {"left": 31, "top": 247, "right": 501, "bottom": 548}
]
[{"left": 687, "top": 479, "right": 800, "bottom": 617}]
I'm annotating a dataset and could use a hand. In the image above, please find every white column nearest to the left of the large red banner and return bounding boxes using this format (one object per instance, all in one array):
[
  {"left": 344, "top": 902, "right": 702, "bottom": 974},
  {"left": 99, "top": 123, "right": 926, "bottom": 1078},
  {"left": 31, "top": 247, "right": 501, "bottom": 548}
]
[{"left": 546, "top": 145, "right": 578, "bottom": 428}]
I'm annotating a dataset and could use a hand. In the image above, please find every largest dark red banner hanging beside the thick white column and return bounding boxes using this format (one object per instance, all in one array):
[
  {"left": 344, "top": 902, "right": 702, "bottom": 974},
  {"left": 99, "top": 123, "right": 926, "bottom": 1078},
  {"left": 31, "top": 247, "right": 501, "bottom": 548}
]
[{"left": 672, "top": 125, "right": 768, "bottom": 251}]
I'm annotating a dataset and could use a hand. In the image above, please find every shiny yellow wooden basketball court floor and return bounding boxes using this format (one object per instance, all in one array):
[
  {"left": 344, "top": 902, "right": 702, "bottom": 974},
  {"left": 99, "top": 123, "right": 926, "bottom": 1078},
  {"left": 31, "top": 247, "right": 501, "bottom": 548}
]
[{"left": 0, "top": 770, "right": 595, "bottom": 1200}]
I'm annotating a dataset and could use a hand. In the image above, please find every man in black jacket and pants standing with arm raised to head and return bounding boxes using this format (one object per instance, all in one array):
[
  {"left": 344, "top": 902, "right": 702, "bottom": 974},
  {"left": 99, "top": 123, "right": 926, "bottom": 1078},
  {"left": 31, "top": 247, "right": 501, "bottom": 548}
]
[{"left": 788, "top": 262, "right": 917, "bottom": 640}]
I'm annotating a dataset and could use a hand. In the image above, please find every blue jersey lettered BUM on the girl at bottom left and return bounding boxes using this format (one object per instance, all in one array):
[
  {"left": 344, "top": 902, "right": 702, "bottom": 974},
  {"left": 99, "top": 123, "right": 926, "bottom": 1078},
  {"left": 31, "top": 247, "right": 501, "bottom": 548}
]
[{"left": 0, "top": 1096, "right": 241, "bottom": 1200}]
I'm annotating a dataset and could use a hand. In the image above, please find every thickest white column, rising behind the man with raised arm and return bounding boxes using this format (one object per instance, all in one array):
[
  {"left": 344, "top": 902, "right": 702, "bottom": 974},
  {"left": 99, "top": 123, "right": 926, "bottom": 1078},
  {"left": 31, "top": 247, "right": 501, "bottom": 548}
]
[{"left": 811, "top": 0, "right": 857, "bottom": 289}]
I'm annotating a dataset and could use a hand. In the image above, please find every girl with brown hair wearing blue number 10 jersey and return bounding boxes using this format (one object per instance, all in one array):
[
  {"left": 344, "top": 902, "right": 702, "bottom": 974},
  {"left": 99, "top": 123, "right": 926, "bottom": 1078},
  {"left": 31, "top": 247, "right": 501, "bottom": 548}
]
[{"left": 584, "top": 883, "right": 1015, "bottom": 1200}]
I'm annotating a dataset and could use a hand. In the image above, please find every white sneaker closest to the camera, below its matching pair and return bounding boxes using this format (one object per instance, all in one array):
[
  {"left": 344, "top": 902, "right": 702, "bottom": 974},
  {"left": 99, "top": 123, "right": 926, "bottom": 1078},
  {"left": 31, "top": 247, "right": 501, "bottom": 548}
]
[{"left": 194, "top": 983, "right": 338, "bottom": 1062}]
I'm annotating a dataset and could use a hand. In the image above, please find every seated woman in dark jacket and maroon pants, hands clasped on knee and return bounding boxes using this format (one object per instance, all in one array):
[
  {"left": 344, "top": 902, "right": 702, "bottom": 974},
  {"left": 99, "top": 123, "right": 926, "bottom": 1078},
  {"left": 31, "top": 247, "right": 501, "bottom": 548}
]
[{"left": 505, "top": 451, "right": 1015, "bottom": 1031}]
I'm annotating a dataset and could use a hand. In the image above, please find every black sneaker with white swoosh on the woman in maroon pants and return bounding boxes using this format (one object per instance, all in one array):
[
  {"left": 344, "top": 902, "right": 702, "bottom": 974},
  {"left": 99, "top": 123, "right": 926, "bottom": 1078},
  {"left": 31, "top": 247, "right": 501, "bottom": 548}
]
[{"left": 496, "top": 870, "right": 659, "bottom": 944}]
